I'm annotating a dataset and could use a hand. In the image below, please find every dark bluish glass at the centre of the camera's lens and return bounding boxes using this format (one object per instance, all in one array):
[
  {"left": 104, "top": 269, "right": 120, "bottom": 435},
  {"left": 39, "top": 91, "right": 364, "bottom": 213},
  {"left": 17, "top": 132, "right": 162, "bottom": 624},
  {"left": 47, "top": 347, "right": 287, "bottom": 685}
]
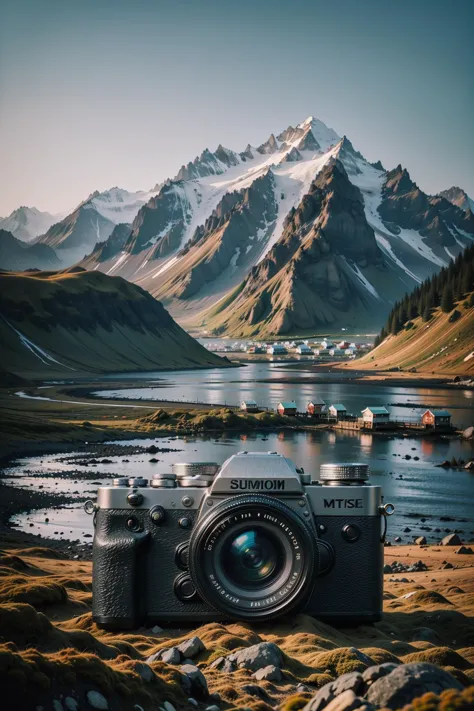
[{"left": 221, "top": 527, "right": 285, "bottom": 588}]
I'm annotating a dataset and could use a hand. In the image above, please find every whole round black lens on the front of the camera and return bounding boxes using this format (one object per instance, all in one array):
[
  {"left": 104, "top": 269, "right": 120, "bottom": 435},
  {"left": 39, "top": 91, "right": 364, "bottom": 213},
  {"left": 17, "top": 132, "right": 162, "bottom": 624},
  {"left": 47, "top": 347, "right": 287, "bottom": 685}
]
[{"left": 189, "top": 494, "right": 319, "bottom": 620}]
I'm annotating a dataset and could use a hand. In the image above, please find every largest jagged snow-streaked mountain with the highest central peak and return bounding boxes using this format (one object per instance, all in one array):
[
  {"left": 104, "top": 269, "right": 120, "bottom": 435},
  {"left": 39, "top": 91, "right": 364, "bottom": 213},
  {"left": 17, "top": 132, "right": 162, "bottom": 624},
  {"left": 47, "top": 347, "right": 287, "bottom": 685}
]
[{"left": 79, "top": 117, "right": 474, "bottom": 335}]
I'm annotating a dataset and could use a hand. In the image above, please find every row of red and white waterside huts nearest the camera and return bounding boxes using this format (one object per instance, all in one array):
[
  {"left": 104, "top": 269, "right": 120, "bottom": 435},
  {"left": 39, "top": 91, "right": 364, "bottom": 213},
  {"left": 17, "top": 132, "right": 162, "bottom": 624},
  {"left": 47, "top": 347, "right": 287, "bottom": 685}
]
[{"left": 240, "top": 398, "right": 455, "bottom": 432}]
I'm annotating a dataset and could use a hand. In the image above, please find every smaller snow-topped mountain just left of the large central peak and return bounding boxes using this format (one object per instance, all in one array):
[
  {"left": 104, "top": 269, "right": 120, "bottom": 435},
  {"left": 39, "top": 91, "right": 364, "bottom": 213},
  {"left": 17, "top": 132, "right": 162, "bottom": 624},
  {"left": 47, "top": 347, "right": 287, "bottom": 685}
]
[{"left": 35, "top": 188, "right": 157, "bottom": 266}]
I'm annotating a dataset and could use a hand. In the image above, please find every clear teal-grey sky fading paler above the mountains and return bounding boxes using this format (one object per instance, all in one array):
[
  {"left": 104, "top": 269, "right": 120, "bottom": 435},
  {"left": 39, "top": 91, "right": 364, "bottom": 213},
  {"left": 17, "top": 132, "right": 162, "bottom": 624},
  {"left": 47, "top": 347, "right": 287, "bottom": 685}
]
[{"left": 0, "top": 0, "right": 474, "bottom": 216}]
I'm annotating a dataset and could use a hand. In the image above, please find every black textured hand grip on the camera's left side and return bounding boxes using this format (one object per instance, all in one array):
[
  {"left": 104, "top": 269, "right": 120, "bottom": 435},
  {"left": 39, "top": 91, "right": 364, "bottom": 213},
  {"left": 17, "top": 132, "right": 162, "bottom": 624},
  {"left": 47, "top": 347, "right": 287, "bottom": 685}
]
[{"left": 92, "top": 511, "right": 149, "bottom": 628}]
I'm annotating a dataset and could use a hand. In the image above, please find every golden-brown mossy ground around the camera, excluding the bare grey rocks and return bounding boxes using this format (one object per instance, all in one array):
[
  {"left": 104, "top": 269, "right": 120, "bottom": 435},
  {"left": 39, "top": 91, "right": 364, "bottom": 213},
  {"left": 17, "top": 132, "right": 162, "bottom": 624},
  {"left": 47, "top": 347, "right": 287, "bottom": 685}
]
[{"left": 0, "top": 544, "right": 474, "bottom": 711}]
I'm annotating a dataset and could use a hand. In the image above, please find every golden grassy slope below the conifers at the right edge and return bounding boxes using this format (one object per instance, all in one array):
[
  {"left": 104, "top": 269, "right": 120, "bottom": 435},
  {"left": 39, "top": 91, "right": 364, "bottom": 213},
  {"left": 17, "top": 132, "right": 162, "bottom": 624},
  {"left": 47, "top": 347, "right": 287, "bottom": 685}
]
[{"left": 347, "top": 304, "right": 474, "bottom": 375}]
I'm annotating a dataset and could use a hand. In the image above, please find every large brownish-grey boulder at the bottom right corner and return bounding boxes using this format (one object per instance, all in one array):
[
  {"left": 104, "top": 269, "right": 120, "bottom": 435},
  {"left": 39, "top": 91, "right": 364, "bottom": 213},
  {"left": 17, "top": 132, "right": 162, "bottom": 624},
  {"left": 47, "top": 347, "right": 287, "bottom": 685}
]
[{"left": 366, "top": 662, "right": 463, "bottom": 711}]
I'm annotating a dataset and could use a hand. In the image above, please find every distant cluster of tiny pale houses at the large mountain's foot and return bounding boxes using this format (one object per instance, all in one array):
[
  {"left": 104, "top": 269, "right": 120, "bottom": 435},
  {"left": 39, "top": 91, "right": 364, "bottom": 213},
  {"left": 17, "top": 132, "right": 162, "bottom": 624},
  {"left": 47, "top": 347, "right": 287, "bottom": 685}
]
[{"left": 202, "top": 338, "right": 373, "bottom": 360}]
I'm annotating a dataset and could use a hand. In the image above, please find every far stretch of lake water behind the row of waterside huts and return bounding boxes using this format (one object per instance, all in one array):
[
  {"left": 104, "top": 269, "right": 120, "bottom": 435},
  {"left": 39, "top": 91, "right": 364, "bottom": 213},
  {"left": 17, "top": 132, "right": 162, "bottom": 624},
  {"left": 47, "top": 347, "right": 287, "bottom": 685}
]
[{"left": 95, "top": 362, "right": 474, "bottom": 427}]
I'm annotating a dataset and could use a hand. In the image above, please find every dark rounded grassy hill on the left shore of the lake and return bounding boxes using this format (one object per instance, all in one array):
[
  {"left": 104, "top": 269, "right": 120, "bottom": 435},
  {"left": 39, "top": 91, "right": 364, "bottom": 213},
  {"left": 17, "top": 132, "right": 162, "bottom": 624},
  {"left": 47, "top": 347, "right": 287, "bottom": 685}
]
[{"left": 0, "top": 271, "right": 226, "bottom": 378}]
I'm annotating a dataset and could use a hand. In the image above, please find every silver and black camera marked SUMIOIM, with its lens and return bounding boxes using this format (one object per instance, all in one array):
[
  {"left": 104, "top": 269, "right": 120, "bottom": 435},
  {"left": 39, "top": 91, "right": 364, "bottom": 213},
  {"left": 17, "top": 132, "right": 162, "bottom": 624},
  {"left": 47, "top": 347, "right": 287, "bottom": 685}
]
[{"left": 86, "top": 452, "right": 394, "bottom": 629}]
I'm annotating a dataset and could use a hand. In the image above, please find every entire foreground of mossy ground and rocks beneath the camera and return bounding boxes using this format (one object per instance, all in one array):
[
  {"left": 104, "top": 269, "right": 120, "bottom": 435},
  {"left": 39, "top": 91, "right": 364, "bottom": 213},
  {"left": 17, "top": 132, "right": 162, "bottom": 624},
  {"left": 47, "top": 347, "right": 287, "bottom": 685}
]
[{"left": 0, "top": 544, "right": 474, "bottom": 711}]
